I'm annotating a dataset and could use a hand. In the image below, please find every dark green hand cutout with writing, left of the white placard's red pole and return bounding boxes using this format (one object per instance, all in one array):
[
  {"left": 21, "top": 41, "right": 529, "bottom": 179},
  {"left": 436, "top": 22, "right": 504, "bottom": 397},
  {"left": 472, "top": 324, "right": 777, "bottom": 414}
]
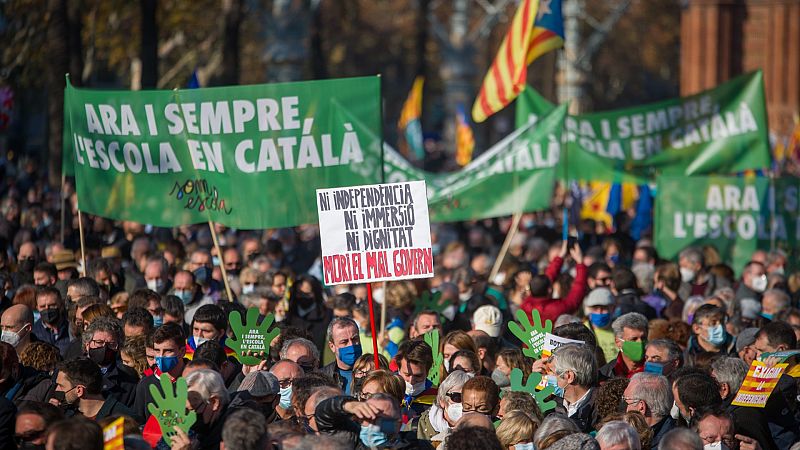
[{"left": 225, "top": 308, "right": 280, "bottom": 366}]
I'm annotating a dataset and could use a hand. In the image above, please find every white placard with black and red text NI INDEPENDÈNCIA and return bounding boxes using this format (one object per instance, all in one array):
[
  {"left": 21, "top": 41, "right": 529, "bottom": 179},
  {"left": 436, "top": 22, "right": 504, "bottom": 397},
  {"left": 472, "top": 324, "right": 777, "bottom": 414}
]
[{"left": 317, "top": 181, "right": 433, "bottom": 285}]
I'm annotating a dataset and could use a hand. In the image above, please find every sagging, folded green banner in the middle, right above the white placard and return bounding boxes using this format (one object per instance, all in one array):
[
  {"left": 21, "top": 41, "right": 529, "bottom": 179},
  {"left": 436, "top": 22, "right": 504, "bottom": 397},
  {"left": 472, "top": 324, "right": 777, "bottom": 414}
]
[{"left": 384, "top": 105, "right": 566, "bottom": 222}]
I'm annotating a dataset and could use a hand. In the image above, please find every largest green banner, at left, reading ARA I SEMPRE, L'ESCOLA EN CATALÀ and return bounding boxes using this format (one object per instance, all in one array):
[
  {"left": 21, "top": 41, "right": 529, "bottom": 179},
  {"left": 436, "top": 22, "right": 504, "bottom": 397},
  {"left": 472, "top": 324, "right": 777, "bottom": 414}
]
[{"left": 64, "top": 77, "right": 381, "bottom": 229}]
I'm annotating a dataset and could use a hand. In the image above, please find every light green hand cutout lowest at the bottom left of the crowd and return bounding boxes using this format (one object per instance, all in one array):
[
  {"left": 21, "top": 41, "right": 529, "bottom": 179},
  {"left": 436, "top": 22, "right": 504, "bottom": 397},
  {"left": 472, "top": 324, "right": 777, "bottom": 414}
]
[{"left": 147, "top": 374, "right": 197, "bottom": 444}]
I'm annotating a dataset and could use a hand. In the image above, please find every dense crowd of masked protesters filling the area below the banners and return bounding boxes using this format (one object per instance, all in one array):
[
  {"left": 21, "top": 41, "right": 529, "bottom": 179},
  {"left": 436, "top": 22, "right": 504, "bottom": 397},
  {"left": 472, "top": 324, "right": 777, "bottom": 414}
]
[{"left": 0, "top": 160, "right": 800, "bottom": 450}]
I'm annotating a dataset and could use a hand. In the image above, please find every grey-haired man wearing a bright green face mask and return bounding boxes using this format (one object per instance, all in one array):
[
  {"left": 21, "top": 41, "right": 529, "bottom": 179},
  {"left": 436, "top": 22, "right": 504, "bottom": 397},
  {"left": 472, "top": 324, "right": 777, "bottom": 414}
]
[{"left": 600, "top": 312, "right": 648, "bottom": 382}]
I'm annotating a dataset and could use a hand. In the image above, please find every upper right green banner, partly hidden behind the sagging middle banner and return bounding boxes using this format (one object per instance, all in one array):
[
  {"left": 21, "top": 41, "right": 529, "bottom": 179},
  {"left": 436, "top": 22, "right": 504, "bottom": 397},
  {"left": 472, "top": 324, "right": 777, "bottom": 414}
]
[{"left": 516, "top": 71, "right": 771, "bottom": 183}]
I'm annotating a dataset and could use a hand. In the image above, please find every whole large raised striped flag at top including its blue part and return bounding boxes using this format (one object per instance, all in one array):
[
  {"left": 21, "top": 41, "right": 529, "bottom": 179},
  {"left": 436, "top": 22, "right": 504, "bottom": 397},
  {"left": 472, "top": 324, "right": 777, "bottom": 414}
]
[{"left": 472, "top": 0, "right": 564, "bottom": 123}]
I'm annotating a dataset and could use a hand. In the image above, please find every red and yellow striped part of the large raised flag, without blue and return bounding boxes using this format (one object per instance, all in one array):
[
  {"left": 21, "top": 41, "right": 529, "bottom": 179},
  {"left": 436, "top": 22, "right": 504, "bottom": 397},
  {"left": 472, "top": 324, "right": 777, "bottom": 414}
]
[{"left": 472, "top": 0, "right": 539, "bottom": 123}]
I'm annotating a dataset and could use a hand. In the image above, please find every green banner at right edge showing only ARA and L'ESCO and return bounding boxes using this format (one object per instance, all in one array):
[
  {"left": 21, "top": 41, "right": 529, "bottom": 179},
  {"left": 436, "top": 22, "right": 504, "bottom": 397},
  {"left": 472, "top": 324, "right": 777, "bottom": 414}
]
[{"left": 655, "top": 176, "right": 800, "bottom": 273}]
